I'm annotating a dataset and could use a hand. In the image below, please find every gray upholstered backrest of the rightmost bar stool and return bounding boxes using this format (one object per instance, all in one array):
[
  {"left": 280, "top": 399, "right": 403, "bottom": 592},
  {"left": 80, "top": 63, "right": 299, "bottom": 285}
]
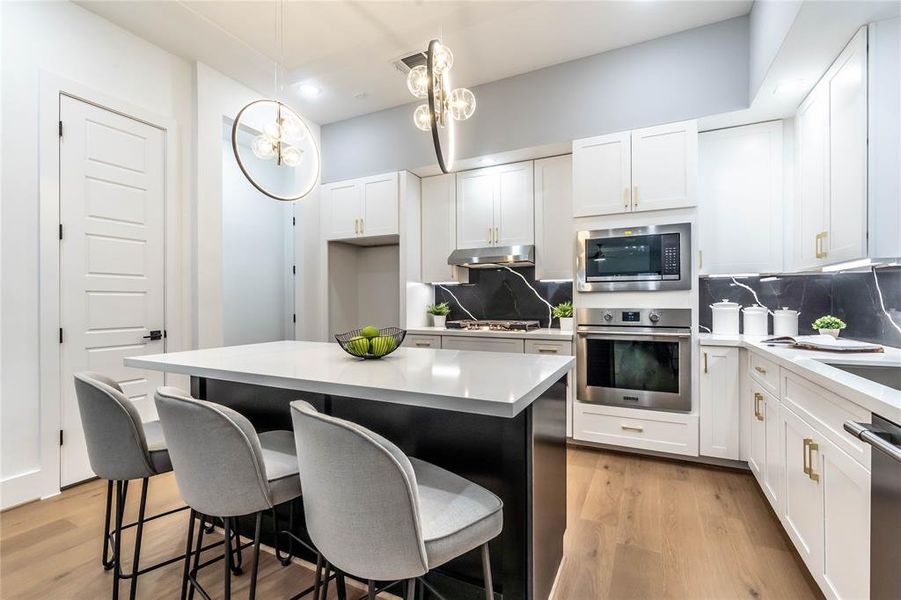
[{"left": 291, "top": 400, "right": 428, "bottom": 580}]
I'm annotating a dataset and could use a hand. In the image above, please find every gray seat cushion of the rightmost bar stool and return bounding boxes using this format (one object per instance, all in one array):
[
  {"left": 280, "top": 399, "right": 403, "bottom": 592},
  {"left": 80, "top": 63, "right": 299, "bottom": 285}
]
[{"left": 410, "top": 457, "right": 504, "bottom": 569}]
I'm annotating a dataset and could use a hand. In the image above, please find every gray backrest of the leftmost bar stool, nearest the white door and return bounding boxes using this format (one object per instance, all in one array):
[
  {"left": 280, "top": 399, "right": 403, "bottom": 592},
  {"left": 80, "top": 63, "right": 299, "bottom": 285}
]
[{"left": 75, "top": 371, "right": 156, "bottom": 480}]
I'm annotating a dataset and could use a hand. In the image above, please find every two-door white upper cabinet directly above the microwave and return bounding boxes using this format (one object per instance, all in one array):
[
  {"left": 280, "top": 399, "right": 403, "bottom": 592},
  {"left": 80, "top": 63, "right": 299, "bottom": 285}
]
[{"left": 573, "top": 121, "right": 698, "bottom": 217}]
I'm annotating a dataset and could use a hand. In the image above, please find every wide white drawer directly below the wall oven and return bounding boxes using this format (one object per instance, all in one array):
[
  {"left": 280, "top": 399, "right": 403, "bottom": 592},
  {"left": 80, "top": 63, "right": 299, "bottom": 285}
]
[{"left": 573, "top": 401, "right": 698, "bottom": 456}]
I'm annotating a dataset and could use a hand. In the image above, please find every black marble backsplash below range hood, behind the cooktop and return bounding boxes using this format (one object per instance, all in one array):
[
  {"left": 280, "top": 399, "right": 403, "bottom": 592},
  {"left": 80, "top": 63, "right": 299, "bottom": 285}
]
[{"left": 435, "top": 267, "right": 573, "bottom": 327}]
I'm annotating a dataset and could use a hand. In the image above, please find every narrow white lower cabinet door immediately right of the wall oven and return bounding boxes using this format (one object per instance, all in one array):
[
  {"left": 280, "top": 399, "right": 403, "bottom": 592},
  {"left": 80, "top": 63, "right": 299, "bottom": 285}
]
[{"left": 699, "top": 346, "right": 739, "bottom": 460}]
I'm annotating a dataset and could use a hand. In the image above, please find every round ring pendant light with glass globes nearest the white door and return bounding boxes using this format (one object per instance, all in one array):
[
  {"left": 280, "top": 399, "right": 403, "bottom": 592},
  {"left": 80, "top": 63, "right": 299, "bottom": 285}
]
[{"left": 231, "top": 0, "right": 320, "bottom": 201}]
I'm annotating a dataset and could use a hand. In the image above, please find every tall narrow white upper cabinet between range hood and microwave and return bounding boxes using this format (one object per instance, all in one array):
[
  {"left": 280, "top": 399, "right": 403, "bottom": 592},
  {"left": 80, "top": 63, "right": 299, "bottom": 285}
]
[{"left": 535, "top": 155, "right": 575, "bottom": 279}]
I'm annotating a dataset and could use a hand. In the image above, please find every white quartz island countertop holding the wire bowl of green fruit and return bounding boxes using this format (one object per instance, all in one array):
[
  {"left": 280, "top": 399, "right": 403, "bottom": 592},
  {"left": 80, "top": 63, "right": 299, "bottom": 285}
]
[{"left": 125, "top": 341, "right": 575, "bottom": 417}]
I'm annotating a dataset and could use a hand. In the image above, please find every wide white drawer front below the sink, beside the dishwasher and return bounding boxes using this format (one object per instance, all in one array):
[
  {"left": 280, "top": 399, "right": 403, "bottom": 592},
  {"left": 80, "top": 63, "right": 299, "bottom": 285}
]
[{"left": 783, "top": 371, "right": 872, "bottom": 469}]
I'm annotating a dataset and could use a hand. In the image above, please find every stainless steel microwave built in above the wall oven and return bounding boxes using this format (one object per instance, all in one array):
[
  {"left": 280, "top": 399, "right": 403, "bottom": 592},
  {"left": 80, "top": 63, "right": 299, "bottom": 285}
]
[{"left": 576, "top": 223, "right": 691, "bottom": 292}]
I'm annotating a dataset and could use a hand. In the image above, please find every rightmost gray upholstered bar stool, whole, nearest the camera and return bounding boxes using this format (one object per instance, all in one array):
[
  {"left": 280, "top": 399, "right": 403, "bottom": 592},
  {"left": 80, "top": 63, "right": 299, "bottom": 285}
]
[{"left": 291, "top": 400, "right": 504, "bottom": 600}]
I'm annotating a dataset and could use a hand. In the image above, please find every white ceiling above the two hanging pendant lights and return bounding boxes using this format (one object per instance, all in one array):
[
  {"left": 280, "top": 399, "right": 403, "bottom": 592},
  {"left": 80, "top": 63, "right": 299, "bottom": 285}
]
[{"left": 77, "top": 0, "right": 752, "bottom": 124}]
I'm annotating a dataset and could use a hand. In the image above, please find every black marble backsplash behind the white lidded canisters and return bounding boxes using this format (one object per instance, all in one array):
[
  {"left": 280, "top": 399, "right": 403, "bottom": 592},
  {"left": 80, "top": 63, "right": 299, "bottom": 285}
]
[{"left": 698, "top": 267, "right": 901, "bottom": 347}]
